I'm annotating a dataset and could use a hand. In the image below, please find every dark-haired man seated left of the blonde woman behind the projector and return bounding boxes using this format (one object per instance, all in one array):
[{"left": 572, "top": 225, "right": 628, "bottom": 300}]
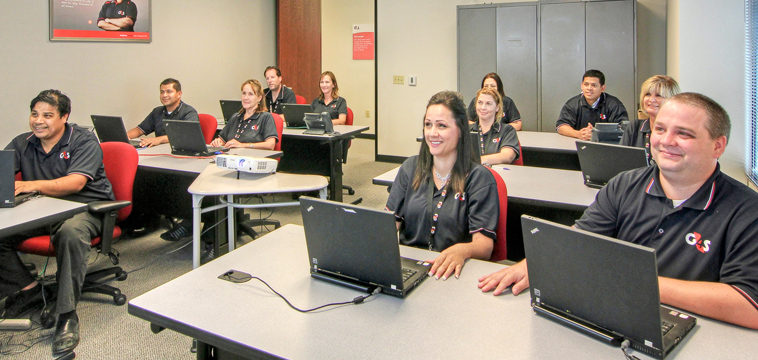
[{"left": 127, "top": 78, "right": 200, "bottom": 147}]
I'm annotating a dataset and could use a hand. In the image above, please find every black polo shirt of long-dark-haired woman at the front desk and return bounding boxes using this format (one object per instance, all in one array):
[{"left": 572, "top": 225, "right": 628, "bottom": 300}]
[{"left": 387, "top": 155, "right": 500, "bottom": 251}]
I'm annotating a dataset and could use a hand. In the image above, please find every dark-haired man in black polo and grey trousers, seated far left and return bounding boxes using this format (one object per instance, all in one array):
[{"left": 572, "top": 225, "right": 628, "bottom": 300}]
[{"left": 0, "top": 90, "right": 114, "bottom": 354}]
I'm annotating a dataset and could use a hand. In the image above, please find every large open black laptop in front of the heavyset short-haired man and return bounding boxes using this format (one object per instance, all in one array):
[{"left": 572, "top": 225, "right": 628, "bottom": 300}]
[{"left": 521, "top": 215, "right": 697, "bottom": 359}]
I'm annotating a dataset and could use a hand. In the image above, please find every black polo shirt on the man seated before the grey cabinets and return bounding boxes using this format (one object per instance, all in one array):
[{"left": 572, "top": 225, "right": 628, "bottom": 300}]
[{"left": 555, "top": 93, "right": 629, "bottom": 130}]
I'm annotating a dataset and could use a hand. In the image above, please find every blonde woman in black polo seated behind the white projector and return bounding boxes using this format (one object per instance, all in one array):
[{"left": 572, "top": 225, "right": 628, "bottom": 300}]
[{"left": 211, "top": 80, "right": 279, "bottom": 150}]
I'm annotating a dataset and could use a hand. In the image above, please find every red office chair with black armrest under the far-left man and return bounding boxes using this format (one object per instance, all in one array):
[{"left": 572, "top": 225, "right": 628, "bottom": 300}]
[{"left": 16, "top": 142, "right": 139, "bottom": 327}]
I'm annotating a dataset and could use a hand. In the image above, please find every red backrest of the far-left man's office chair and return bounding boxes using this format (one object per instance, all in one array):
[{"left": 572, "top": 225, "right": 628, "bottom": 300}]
[{"left": 100, "top": 142, "right": 139, "bottom": 221}]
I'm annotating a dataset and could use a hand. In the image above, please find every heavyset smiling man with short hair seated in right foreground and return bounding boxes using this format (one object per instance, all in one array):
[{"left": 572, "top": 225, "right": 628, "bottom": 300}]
[{"left": 479, "top": 93, "right": 758, "bottom": 329}]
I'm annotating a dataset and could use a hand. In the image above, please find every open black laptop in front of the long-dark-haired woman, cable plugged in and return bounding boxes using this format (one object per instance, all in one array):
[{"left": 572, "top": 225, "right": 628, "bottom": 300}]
[{"left": 300, "top": 196, "right": 431, "bottom": 297}]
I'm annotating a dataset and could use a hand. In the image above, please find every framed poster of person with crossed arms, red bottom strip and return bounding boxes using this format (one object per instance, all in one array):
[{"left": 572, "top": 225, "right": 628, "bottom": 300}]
[{"left": 49, "top": 0, "right": 152, "bottom": 42}]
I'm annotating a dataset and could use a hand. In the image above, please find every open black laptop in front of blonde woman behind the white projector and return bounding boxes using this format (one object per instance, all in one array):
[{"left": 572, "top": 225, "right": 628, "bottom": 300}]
[{"left": 163, "top": 119, "right": 229, "bottom": 156}]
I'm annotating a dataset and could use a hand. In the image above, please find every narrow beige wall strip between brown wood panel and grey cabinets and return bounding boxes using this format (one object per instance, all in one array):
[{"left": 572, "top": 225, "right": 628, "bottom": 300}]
[{"left": 324, "top": 0, "right": 375, "bottom": 133}]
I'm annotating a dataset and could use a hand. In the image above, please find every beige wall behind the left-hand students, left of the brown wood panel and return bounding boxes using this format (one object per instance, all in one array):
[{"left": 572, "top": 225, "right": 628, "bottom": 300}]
[{"left": 0, "top": 0, "right": 276, "bottom": 147}]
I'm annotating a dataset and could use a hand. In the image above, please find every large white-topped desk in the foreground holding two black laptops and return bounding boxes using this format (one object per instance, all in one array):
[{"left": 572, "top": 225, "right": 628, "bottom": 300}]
[{"left": 128, "top": 225, "right": 756, "bottom": 360}]
